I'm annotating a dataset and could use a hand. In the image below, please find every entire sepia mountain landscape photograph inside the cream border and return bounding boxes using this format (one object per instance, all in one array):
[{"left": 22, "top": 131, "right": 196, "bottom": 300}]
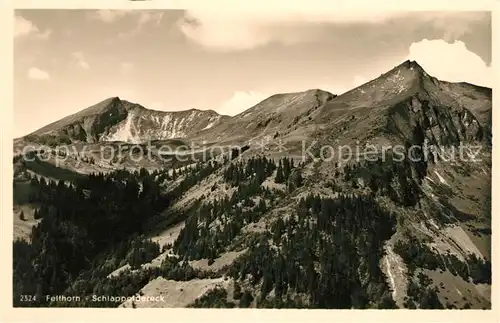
[{"left": 6, "top": 1, "right": 494, "bottom": 311}]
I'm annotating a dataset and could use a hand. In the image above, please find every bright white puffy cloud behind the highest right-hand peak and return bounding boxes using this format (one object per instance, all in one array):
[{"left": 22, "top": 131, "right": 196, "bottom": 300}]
[{"left": 408, "top": 39, "right": 493, "bottom": 87}]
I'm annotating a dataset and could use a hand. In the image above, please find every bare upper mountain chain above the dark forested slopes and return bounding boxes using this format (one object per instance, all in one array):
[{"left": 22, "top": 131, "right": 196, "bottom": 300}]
[{"left": 16, "top": 61, "right": 491, "bottom": 150}]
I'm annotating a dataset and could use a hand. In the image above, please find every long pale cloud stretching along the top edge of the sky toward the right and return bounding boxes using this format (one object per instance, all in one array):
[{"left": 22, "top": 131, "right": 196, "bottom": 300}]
[{"left": 177, "top": 8, "right": 488, "bottom": 51}]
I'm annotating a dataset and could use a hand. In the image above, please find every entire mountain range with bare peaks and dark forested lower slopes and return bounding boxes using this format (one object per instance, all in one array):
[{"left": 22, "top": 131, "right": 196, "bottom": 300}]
[{"left": 14, "top": 61, "right": 492, "bottom": 308}]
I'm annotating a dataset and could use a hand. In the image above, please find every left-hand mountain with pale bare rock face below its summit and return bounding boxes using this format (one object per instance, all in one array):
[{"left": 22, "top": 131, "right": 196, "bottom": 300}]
[{"left": 26, "top": 97, "right": 227, "bottom": 144}]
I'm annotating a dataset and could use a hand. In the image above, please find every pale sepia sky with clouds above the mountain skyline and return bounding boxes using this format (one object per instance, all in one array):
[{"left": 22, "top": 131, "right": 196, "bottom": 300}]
[{"left": 14, "top": 6, "right": 493, "bottom": 137}]
